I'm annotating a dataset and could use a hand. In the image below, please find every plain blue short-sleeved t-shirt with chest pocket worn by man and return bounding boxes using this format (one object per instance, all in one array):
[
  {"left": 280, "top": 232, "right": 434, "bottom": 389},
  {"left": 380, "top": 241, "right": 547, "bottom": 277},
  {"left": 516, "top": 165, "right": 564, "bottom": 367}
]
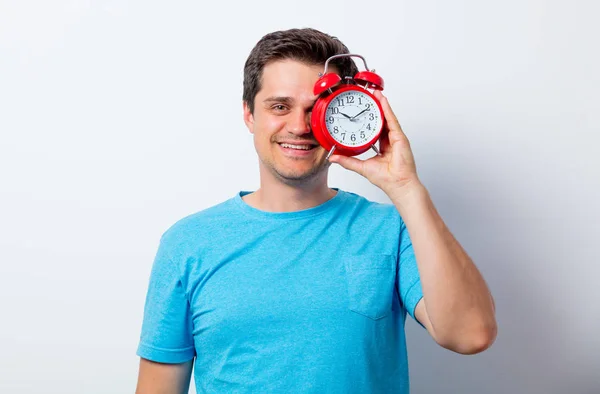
[{"left": 137, "top": 189, "right": 422, "bottom": 394}]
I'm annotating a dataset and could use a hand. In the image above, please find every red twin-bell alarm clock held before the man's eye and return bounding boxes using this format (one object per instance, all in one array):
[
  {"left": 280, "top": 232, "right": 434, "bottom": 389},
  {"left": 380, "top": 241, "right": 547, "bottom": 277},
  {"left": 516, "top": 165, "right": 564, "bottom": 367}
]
[{"left": 310, "top": 54, "right": 385, "bottom": 159}]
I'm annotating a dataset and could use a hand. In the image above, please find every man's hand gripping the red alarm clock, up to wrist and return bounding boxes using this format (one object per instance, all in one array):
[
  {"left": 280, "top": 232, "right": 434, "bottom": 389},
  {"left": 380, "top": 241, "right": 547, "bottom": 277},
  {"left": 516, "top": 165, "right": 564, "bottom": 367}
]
[{"left": 329, "top": 91, "right": 422, "bottom": 202}]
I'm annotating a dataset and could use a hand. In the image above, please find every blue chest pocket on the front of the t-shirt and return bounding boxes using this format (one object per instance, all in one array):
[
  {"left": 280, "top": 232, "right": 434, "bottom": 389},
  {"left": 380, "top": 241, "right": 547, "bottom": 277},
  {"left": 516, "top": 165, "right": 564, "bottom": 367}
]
[{"left": 344, "top": 254, "right": 396, "bottom": 320}]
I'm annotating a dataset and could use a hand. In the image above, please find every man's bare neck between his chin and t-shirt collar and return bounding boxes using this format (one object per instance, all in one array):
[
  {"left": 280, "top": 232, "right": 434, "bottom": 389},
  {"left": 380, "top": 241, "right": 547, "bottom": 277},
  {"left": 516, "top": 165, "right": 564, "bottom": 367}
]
[{"left": 243, "top": 170, "right": 337, "bottom": 212}]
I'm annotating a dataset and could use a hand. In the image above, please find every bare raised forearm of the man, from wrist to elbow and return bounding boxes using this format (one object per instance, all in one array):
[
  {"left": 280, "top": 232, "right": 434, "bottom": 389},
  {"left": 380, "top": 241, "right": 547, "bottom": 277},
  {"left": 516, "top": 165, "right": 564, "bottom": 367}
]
[{"left": 391, "top": 185, "right": 496, "bottom": 348}]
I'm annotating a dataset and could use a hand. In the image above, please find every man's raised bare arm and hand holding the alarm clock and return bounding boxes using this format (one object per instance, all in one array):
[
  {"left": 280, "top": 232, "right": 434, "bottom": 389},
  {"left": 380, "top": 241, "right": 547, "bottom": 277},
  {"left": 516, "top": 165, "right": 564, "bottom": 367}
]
[{"left": 329, "top": 91, "right": 497, "bottom": 354}]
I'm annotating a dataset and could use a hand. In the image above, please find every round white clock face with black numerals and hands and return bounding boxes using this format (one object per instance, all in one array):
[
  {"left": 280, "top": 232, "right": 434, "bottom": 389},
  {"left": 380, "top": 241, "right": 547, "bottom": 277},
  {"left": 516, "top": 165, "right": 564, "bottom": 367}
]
[{"left": 325, "top": 90, "right": 382, "bottom": 146}]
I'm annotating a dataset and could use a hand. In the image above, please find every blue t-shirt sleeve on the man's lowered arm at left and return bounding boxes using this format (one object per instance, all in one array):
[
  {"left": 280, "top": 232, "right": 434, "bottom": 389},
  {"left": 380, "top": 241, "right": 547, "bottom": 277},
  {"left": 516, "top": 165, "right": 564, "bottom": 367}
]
[{"left": 136, "top": 239, "right": 196, "bottom": 363}]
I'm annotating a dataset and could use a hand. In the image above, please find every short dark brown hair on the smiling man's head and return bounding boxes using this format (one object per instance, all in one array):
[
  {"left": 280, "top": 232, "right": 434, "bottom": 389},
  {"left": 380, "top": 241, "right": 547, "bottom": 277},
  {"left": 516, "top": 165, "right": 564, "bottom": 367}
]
[{"left": 242, "top": 28, "right": 358, "bottom": 113}]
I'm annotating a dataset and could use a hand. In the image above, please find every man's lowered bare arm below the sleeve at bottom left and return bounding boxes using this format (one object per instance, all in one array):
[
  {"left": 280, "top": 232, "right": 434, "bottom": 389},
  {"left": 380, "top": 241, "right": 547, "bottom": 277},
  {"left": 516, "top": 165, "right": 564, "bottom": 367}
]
[{"left": 135, "top": 358, "right": 194, "bottom": 394}]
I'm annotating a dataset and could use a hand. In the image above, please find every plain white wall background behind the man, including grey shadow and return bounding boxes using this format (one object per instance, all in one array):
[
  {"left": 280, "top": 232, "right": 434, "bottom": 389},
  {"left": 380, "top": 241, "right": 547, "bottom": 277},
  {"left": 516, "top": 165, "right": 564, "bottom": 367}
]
[{"left": 0, "top": 0, "right": 600, "bottom": 394}]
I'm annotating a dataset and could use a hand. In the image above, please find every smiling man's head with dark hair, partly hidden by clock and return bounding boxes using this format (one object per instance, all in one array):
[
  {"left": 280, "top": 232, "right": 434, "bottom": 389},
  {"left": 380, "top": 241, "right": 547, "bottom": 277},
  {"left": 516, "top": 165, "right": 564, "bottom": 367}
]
[{"left": 243, "top": 29, "right": 358, "bottom": 184}]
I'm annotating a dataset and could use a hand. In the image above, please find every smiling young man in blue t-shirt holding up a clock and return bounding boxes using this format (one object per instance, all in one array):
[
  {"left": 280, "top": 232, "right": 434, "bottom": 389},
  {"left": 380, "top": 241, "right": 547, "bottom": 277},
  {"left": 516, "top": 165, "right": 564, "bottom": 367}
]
[{"left": 137, "top": 29, "right": 496, "bottom": 394}]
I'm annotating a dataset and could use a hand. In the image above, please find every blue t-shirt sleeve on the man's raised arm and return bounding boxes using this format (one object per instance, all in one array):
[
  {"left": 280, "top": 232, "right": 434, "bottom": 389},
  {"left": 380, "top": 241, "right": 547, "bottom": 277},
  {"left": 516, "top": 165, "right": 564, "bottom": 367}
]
[{"left": 398, "top": 221, "right": 423, "bottom": 322}]
